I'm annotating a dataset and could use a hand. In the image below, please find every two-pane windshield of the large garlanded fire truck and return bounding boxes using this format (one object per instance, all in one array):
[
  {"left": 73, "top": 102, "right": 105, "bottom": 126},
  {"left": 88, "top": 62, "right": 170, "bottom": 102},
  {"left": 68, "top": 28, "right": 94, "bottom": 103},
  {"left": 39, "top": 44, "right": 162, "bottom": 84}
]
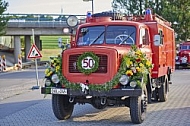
[{"left": 77, "top": 25, "right": 136, "bottom": 46}]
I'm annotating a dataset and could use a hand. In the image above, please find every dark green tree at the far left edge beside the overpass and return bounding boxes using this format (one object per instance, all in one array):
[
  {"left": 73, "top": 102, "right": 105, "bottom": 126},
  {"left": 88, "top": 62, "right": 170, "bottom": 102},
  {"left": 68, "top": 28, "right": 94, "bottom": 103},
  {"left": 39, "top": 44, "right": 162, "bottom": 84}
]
[{"left": 0, "top": 0, "right": 9, "bottom": 36}]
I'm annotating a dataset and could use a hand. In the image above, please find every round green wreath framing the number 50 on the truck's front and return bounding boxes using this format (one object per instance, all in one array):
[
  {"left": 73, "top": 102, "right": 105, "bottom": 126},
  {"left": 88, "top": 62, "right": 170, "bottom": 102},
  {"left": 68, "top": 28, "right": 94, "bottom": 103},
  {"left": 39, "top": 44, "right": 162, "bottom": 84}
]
[{"left": 77, "top": 52, "right": 99, "bottom": 75}]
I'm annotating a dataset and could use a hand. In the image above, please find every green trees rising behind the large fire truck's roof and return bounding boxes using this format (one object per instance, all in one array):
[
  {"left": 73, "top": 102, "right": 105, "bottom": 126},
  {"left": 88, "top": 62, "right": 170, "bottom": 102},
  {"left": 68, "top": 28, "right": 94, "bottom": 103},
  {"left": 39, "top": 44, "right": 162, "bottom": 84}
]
[{"left": 112, "top": 0, "right": 190, "bottom": 41}]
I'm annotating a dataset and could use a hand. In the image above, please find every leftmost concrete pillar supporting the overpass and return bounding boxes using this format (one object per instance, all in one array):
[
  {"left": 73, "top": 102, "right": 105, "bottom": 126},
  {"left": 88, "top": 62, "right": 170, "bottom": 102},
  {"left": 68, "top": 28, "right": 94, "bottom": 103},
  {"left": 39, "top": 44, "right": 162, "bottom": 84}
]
[{"left": 14, "top": 36, "right": 21, "bottom": 63}]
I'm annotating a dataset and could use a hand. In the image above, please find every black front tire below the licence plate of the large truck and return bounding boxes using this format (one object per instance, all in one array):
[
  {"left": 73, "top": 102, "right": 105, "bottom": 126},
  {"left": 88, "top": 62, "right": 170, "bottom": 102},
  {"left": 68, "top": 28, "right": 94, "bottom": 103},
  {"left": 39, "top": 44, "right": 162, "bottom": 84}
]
[{"left": 52, "top": 94, "right": 74, "bottom": 120}]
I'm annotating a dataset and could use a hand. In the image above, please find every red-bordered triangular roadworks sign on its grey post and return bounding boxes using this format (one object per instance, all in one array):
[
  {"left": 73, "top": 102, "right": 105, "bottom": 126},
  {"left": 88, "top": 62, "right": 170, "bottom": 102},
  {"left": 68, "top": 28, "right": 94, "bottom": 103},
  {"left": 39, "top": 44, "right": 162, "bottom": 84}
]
[{"left": 27, "top": 29, "right": 42, "bottom": 89}]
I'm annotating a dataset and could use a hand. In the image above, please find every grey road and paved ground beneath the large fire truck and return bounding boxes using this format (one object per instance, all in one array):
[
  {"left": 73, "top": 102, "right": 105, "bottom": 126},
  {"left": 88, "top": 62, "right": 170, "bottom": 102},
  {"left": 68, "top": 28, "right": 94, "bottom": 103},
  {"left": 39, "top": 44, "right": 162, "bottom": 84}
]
[{"left": 0, "top": 69, "right": 190, "bottom": 126}]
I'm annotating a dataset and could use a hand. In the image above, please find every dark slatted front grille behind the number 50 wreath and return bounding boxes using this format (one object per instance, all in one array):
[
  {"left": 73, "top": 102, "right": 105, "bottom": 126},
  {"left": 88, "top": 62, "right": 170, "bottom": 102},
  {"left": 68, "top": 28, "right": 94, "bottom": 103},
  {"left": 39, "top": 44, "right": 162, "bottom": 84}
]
[{"left": 69, "top": 54, "right": 108, "bottom": 73}]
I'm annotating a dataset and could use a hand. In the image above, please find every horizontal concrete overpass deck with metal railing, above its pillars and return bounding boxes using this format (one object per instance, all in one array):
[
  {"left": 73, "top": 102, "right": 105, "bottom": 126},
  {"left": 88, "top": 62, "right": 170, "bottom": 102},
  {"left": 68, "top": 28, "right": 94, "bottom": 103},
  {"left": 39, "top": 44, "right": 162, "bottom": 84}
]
[{"left": 6, "top": 21, "right": 68, "bottom": 36}]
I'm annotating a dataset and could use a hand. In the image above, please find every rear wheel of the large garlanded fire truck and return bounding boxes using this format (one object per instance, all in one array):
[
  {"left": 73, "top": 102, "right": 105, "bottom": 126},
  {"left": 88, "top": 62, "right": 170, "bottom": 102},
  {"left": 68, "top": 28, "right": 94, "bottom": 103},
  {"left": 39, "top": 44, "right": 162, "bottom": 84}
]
[{"left": 158, "top": 76, "right": 169, "bottom": 102}]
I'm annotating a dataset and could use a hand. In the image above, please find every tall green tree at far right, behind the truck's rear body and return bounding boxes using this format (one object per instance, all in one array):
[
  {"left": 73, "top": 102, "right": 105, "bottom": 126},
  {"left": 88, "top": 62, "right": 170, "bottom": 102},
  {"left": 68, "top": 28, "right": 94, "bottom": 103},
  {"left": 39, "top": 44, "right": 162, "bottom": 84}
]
[{"left": 163, "top": 0, "right": 190, "bottom": 41}]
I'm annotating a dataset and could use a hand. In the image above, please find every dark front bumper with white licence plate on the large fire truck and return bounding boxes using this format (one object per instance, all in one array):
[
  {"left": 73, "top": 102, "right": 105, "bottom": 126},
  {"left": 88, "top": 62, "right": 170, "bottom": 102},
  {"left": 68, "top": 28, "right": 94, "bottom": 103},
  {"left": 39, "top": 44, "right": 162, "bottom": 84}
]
[{"left": 41, "top": 87, "right": 142, "bottom": 97}]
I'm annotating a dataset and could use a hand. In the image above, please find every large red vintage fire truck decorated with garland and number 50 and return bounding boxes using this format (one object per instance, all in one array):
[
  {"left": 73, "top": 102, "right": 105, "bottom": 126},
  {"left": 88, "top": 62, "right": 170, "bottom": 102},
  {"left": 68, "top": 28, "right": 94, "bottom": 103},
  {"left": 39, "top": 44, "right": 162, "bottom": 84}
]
[{"left": 41, "top": 9, "right": 175, "bottom": 124}]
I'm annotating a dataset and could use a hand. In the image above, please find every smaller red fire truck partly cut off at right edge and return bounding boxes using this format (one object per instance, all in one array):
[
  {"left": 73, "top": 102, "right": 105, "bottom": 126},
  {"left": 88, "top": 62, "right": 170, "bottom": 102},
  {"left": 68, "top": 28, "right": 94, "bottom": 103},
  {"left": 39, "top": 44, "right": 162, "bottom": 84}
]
[{"left": 176, "top": 41, "right": 190, "bottom": 68}]
